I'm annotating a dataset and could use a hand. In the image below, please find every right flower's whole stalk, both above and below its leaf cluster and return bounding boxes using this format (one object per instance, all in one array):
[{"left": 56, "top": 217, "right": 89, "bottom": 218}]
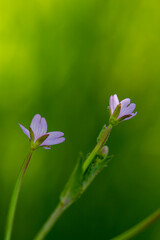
[{"left": 34, "top": 124, "right": 112, "bottom": 240}]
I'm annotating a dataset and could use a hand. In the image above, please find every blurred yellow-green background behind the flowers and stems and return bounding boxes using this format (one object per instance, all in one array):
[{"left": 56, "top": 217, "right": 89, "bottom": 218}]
[{"left": 0, "top": 0, "right": 160, "bottom": 240}]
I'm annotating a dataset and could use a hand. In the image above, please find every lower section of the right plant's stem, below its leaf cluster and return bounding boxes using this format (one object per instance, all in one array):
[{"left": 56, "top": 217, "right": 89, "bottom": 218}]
[{"left": 34, "top": 203, "right": 68, "bottom": 240}]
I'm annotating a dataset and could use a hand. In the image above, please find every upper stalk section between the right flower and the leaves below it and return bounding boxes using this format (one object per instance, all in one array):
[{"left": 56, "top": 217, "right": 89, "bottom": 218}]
[{"left": 83, "top": 124, "right": 112, "bottom": 172}]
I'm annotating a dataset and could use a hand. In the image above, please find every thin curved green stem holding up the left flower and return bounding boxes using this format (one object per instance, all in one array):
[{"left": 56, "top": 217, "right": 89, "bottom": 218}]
[{"left": 4, "top": 151, "right": 32, "bottom": 240}]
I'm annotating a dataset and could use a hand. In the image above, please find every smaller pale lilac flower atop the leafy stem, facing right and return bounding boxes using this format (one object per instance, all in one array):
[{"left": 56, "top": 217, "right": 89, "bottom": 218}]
[{"left": 109, "top": 94, "right": 137, "bottom": 125}]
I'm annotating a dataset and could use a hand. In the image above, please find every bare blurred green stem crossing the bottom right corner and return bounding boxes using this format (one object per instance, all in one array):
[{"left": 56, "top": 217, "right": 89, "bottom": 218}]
[{"left": 111, "top": 209, "right": 160, "bottom": 240}]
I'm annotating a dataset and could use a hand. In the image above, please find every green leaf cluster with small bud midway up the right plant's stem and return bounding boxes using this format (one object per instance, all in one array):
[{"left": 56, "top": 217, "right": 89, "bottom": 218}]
[{"left": 60, "top": 146, "right": 113, "bottom": 206}]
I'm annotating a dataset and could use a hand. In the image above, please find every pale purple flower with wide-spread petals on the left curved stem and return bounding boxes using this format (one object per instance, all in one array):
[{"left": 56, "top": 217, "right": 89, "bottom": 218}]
[{"left": 19, "top": 114, "right": 65, "bottom": 150}]
